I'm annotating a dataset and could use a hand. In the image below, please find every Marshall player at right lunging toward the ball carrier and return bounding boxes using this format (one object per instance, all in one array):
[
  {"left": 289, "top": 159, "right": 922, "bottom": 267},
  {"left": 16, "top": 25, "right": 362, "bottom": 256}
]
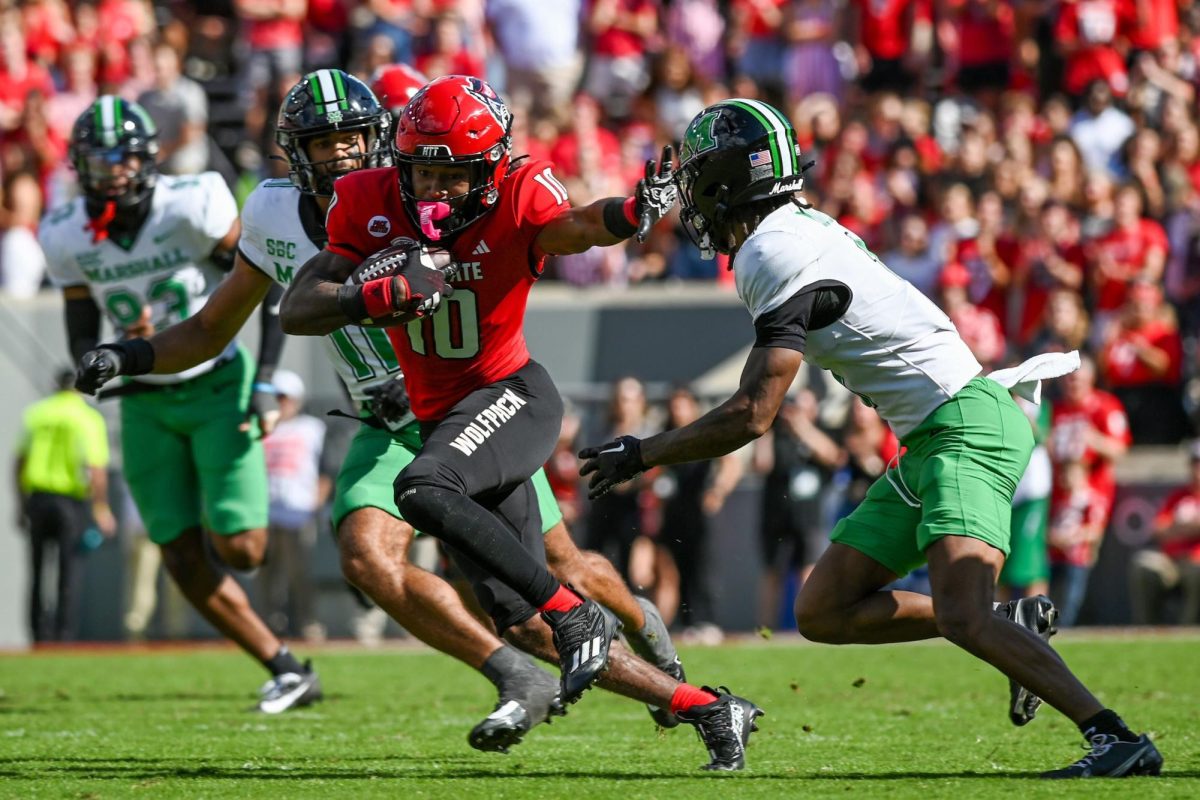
[{"left": 580, "top": 100, "right": 1163, "bottom": 777}]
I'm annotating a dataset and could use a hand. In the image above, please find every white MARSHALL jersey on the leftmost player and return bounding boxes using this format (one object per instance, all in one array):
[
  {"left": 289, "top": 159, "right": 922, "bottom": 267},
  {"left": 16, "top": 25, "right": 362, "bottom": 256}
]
[{"left": 37, "top": 173, "right": 238, "bottom": 384}]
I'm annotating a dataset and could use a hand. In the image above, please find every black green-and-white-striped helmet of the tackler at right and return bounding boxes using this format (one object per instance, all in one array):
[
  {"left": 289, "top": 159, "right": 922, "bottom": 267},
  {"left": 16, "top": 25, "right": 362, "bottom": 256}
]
[{"left": 676, "top": 98, "right": 811, "bottom": 258}]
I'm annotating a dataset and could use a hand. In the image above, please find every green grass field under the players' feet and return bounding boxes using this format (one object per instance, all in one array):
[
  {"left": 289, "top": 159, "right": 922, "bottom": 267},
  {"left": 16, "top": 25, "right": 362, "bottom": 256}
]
[{"left": 0, "top": 634, "right": 1200, "bottom": 800}]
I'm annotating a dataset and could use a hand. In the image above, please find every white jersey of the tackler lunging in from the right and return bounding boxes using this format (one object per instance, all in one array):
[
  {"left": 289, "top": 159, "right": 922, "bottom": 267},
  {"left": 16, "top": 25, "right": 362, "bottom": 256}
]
[{"left": 733, "top": 204, "right": 980, "bottom": 438}]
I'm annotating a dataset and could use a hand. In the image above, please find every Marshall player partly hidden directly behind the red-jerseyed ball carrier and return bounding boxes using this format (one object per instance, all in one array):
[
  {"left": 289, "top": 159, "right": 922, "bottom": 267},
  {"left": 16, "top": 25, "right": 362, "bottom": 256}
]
[{"left": 75, "top": 70, "right": 700, "bottom": 752}]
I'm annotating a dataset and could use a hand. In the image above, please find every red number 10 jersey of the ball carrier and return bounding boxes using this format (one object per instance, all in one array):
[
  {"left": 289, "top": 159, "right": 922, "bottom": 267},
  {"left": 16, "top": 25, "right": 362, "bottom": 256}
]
[{"left": 325, "top": 161, "right": 570, "bottom": 421}]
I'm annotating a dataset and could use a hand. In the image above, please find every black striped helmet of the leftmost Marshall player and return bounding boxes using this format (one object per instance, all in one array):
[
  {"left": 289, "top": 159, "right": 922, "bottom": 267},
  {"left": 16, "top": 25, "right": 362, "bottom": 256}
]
[{"left": 67, "top": 95, "right": 158, "bottom": 209}]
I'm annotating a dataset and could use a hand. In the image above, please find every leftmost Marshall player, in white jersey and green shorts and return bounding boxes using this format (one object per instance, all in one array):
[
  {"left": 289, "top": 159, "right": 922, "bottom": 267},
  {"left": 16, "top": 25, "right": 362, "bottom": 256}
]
[{"left": 45, "top": 95, "right": 320, "bottom": 714}]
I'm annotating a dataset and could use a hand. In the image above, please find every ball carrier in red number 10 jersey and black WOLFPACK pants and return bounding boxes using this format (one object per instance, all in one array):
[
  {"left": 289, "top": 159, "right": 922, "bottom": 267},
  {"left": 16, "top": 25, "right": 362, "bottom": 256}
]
[{"left": 281, "top": 76, "right": 761, "bottom": 769}]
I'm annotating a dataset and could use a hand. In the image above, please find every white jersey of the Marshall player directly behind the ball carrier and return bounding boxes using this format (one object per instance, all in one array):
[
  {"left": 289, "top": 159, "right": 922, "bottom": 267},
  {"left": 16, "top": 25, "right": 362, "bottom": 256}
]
[{"left": 238, "top": 179, "right": 400, "bottom": 419}]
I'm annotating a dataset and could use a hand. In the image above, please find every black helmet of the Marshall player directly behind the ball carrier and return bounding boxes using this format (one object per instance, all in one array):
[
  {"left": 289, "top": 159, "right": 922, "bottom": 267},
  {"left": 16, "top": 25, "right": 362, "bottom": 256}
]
[{"left": 275, "top": 70, "right": 391, "bottom": 197}]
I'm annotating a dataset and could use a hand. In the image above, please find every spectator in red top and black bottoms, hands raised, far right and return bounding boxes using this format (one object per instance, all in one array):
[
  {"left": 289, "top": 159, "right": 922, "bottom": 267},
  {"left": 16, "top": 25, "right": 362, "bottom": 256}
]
[{"left": 1099, "top": 279, "right": 1187, "bottom": 445}]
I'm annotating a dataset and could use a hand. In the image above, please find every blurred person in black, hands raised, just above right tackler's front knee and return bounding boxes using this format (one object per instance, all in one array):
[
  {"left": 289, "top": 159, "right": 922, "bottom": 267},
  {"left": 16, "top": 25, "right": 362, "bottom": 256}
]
[{"left": 752, "top": 387, "right": 846, "bottom": 627}]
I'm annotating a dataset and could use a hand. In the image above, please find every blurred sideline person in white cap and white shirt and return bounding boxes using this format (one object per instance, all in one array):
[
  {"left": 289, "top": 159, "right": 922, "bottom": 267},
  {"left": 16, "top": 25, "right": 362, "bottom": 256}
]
[{"left": 258, "top": 369, "right": 332, "bottom": 642}]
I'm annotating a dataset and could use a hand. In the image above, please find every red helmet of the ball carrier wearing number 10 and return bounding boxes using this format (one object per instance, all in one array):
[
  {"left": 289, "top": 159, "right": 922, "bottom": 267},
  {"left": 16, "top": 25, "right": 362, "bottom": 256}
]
[{"left": 395, "top": 76, "right": 512, "bottom": 239}]
